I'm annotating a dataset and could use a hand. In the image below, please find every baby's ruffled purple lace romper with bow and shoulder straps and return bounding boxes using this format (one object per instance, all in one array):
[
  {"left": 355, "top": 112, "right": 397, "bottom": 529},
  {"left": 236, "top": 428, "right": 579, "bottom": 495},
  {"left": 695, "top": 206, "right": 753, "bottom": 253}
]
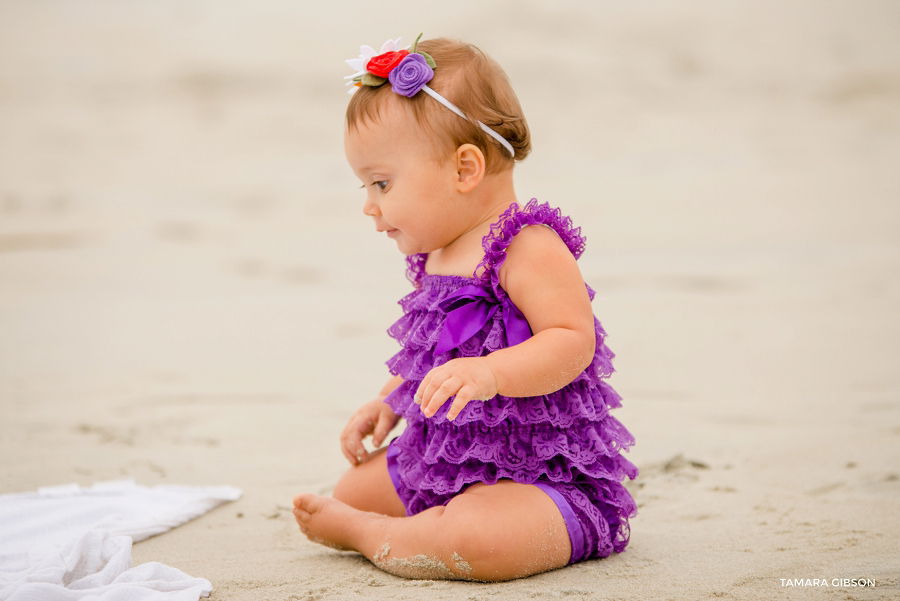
[{"left": 385, "top": 199, "right": 637, "bottom": 563}]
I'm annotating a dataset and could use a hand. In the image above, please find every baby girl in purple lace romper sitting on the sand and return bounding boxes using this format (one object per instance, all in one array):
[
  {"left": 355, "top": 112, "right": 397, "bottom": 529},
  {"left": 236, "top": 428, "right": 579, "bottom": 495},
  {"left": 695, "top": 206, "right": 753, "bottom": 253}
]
[{"left": 294, "top": 34, "right": 637, "bottom": 581}]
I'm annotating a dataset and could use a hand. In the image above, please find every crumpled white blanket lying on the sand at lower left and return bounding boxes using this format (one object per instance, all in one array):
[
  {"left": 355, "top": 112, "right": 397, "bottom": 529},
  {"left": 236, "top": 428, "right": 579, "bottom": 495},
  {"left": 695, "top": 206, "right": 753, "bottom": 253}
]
[{"left": 0, "top": 480, "right": 241, "bottom": 601}]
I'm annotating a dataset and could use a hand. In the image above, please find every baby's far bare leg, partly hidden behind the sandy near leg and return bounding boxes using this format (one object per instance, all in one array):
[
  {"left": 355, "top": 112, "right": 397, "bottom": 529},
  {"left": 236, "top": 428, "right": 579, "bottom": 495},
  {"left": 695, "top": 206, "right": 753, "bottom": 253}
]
[{"left": 332, "top": 447, "right": 406, "bottom": 517}]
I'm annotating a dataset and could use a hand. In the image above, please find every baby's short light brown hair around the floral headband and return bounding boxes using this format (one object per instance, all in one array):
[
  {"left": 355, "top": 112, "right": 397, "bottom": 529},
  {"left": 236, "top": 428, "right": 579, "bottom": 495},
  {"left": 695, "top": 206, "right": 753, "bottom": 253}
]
[{"left": 347, "top": 38, "right": 531, "bottom": 173}]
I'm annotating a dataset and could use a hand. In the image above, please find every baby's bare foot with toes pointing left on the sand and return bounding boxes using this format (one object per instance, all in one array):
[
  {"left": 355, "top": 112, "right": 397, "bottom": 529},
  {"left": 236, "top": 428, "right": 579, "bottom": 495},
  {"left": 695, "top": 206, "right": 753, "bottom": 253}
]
[{"left": 294, "top": 493, "right": 366, "bottom": 551}]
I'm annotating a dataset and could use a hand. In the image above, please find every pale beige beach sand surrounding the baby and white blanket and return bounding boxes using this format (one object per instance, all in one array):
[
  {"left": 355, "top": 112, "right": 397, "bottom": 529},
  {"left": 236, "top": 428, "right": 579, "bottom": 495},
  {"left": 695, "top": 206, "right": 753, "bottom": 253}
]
[{"left": 0, "top": 1, "right": 900, "bottom": 601}]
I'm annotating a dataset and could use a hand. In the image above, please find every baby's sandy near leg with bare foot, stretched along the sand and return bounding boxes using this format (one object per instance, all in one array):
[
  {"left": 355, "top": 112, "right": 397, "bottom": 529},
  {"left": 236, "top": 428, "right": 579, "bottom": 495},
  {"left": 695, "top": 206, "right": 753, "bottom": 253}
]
[{"left": 294, "top": 480, "right": 571, "bottom": 580}]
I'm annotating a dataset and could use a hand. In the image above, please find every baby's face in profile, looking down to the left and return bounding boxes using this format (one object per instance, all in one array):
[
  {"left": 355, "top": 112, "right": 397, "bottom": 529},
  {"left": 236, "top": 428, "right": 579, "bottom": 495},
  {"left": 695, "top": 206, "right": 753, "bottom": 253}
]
[{"left": 344, "top": 98, "right": 466, "bottom": 255}]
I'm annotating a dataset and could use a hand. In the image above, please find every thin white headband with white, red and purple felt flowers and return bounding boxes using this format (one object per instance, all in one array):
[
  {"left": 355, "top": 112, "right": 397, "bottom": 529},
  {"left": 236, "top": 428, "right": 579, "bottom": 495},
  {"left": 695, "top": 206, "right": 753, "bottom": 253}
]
[{"left": 344, "top": 33, "right": 516, "bottom": 157}]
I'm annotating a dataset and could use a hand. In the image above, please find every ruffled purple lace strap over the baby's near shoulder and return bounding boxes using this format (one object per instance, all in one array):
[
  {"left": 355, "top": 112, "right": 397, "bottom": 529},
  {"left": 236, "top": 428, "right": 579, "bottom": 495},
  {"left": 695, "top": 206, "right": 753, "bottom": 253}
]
[{"left": 475, "top": 198, "right": 594, "bottom": 299}]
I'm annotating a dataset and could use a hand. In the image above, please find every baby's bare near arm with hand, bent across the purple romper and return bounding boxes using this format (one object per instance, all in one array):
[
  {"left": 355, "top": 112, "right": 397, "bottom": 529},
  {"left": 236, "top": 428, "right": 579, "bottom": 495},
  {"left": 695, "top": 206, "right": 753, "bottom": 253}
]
[{"left": 416, "top": 226, "right": 596, "bottom": 419}]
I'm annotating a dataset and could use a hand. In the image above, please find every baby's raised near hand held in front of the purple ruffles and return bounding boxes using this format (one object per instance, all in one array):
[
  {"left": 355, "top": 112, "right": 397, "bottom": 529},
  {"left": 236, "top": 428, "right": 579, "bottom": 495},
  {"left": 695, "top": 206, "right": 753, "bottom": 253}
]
[{"left": 415, "top": 357, "right": 499, "bottom": 420}]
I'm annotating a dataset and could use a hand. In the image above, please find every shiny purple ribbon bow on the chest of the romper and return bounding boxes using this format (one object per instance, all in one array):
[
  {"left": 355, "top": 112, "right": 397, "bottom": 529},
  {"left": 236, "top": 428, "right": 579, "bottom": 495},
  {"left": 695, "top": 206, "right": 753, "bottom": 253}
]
[{"left": 434, "top": 284, "right": 531, "bottom": 354}]
